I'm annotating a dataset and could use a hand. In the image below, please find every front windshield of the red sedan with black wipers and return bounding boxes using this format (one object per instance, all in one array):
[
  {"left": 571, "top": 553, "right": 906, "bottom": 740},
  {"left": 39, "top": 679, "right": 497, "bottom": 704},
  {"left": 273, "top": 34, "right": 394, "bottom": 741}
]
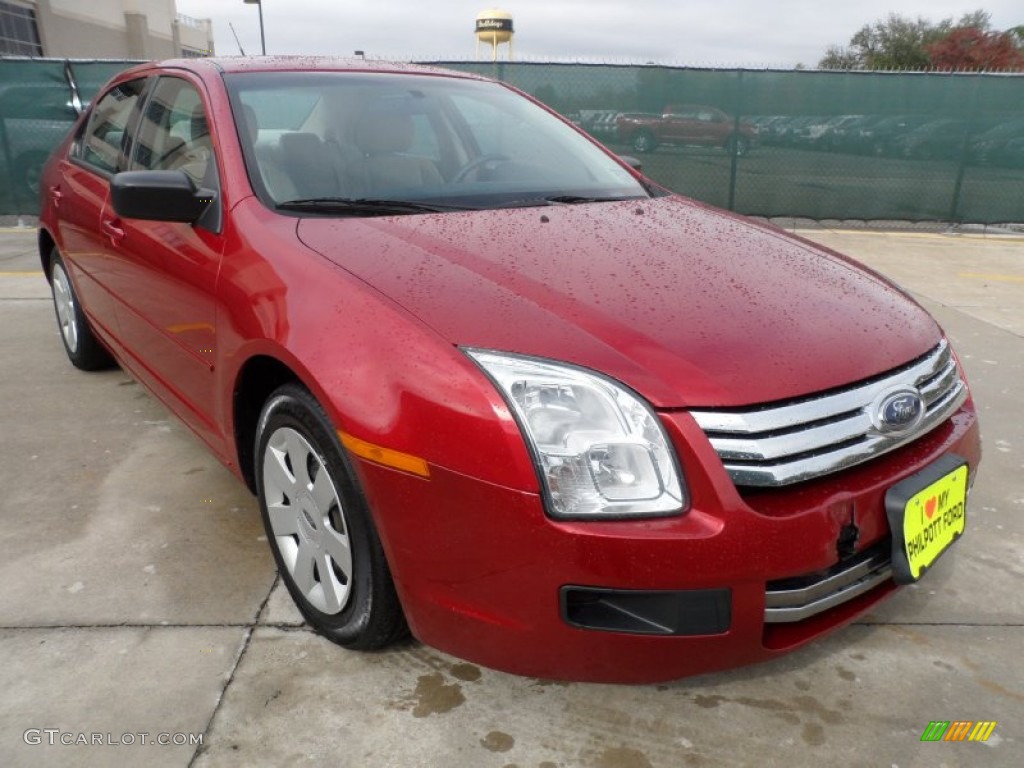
[{"left": 226, "top": 72, "right": 649, "bottom": 215}]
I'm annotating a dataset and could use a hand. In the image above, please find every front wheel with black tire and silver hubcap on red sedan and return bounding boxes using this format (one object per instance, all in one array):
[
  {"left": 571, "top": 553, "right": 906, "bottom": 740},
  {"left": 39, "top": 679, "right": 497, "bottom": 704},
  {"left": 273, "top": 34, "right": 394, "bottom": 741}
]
[{"left": 254, "top": 384, "right": 409, "bottom": 650}]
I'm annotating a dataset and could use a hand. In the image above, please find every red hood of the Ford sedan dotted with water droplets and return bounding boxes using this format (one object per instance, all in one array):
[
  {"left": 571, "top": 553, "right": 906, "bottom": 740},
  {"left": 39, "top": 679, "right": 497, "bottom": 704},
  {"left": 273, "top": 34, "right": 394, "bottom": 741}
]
[{"left": 298, "top": 197, "right": 941, "bottom": 408}]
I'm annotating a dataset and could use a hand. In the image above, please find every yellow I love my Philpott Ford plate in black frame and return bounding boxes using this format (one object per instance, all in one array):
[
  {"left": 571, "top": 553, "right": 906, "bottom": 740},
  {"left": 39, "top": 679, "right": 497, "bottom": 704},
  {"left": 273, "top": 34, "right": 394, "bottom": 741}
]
[{"left": 886, "top": 456, "right": 968, "bottom": 584}]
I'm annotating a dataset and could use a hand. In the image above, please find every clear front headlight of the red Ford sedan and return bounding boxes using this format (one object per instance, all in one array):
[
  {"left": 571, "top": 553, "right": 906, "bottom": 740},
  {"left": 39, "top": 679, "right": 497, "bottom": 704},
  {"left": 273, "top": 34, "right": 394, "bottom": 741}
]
[{"left": 466, "top": 349, "right": 687, "bottom": 518}]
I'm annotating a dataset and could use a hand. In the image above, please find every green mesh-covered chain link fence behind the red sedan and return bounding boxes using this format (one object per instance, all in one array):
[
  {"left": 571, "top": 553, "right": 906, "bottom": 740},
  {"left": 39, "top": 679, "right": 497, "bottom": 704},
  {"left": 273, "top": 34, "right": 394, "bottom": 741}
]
[{"left": 0, "top": 59, "right": 1024, "bottom": 224}]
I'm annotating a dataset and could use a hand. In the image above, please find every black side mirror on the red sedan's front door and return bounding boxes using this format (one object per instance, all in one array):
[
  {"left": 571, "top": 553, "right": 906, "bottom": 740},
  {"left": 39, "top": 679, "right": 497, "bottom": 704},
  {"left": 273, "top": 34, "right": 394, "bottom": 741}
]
[{"left": 111, "top": 171, "right": 214, "bottom": 224}]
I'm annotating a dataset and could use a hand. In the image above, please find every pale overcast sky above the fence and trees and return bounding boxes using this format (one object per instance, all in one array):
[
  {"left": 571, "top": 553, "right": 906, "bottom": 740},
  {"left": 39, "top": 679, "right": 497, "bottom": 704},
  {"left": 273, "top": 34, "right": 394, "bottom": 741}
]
[{"left": 177, "top": 0, "right": 1024, "bottom": 67}]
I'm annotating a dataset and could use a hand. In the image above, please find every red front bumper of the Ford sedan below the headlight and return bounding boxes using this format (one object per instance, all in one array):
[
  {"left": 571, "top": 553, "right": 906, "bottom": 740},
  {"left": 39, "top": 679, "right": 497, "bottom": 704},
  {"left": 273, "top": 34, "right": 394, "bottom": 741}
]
[{"left": 358, "top": 399, "right": 981, "bottom": 683}]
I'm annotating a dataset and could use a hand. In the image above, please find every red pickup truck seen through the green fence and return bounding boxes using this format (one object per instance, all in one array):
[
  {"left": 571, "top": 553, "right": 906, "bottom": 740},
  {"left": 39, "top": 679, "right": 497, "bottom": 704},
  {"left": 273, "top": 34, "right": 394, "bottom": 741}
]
[{"left": 616, "top": 104, "right": 755, "bottom": 156}]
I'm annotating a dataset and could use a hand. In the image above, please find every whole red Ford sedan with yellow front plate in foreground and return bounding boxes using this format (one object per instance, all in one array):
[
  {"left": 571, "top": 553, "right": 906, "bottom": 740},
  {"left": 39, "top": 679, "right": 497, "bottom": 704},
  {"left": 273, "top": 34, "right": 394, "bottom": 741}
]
[{"left": 39, "top": 56, "right": 980, "bottom": 682}]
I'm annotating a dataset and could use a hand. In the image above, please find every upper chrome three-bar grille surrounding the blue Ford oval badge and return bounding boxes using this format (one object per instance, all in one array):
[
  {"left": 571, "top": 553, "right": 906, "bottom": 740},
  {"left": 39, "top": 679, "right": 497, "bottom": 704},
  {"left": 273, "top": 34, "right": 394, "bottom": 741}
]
[{"left": 690, "top": 340, "right": 967, "bottom": 487}]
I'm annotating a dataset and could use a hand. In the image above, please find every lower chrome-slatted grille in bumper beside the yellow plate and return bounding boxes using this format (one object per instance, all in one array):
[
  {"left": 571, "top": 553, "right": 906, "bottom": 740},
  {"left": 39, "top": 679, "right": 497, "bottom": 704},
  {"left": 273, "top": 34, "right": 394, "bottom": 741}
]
[{"left": 765, "top": 542, "right": 892, "bottom": 624}]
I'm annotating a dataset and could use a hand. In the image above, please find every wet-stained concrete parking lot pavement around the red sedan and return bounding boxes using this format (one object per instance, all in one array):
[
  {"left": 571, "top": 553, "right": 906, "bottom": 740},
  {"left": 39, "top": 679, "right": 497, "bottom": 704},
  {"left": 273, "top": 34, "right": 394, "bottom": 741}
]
[{"left": 0, "top": 219, "right": 1024, "bottom": 768}]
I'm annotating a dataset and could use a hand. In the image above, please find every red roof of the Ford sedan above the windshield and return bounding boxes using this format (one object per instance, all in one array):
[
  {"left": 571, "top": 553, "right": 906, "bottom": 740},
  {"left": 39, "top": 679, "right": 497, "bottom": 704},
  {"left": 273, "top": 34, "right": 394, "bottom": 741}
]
[{"left": 116, "top": 56, "right": 487, "bottom": 80}]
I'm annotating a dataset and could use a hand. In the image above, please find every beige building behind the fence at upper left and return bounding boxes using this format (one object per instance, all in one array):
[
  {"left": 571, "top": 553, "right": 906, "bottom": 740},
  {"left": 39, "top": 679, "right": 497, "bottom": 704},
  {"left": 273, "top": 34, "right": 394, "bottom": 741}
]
[{"left": 0, "top": 0, "right": 213, "bottom": 59}]
